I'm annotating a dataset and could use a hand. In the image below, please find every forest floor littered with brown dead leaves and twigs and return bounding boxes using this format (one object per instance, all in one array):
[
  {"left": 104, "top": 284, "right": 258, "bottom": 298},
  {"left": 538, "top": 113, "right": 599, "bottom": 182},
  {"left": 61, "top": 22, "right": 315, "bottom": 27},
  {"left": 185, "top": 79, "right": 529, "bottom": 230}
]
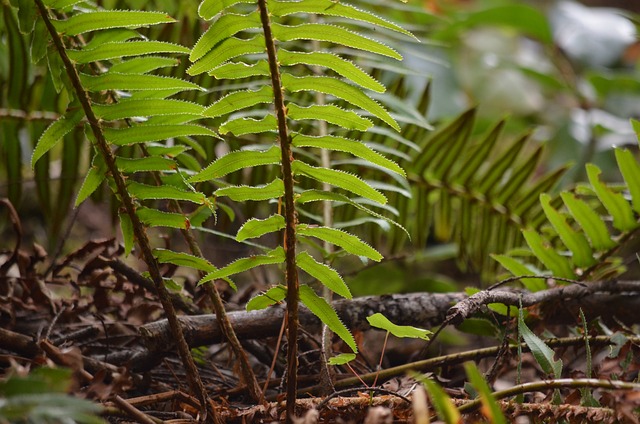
[{"left": 0, "top": 234, "right": 640, "bottom": 424}]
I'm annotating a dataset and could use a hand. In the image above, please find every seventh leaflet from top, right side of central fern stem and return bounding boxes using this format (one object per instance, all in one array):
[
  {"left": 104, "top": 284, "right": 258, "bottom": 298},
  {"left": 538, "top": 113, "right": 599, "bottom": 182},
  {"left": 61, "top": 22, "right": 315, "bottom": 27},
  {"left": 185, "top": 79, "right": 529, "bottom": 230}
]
[{"left": 292, "top": 160, "right": 387, "bottom": 205}]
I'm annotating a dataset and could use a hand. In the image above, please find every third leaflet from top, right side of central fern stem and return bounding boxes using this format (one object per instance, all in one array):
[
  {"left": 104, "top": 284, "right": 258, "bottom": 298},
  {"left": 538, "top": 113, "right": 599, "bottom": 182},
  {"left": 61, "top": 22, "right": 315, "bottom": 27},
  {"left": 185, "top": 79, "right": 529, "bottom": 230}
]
[{"left": 278, "top": 49, "right": 385, "bottom": 93}]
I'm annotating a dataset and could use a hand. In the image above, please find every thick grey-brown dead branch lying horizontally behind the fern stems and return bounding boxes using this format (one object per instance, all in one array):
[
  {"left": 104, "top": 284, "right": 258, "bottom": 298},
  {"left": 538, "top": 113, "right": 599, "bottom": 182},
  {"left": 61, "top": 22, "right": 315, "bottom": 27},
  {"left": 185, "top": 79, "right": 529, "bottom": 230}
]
[{"left": 140, "top": 281, "right": 640, "bottom": 351}]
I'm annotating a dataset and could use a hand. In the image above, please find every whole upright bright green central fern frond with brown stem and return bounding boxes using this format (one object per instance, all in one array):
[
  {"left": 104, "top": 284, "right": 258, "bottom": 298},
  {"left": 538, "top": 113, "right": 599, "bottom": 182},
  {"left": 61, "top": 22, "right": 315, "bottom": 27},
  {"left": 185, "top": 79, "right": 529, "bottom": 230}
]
[{"left": 188, "top": 0, "right": 411, "bottom": 421}]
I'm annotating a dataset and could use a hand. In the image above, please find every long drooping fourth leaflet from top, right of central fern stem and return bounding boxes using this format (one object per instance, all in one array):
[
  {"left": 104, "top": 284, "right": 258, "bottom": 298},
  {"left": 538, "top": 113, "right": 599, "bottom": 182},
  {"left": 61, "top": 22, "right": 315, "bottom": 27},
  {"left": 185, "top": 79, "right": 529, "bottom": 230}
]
[{"left": 282, "top": 74, "right": 400, "bottom": 131}]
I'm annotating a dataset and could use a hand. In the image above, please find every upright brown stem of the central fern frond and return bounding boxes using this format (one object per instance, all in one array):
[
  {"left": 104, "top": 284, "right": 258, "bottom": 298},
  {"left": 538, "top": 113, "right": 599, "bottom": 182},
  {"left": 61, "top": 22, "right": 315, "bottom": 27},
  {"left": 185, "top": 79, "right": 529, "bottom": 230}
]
[{"left": 258, "top": 0, "right": 299, "bottom": 423}]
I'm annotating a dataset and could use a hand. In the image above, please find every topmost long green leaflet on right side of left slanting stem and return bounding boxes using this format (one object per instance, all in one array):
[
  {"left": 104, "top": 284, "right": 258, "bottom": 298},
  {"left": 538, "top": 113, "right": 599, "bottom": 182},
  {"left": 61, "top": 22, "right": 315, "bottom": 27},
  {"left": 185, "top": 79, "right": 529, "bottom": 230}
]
[{"left": 53, "top": 10, "right": 176, "bottom": 36}]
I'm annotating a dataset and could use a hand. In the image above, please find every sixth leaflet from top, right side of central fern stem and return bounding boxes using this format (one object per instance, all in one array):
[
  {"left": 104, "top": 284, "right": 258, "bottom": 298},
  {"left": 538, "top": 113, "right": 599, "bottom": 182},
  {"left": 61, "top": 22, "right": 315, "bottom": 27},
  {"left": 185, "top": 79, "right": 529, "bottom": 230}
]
[{"left": 291, "top": 133, "right": 406, "bottom": 176}]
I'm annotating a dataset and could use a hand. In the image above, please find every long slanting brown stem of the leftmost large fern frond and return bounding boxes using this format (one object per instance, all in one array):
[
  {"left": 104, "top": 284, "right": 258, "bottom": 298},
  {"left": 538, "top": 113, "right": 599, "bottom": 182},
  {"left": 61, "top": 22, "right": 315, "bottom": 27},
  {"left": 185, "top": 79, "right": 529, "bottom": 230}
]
[{"left": 35, "top": 0, "right": 219, "bottom": 423}]
